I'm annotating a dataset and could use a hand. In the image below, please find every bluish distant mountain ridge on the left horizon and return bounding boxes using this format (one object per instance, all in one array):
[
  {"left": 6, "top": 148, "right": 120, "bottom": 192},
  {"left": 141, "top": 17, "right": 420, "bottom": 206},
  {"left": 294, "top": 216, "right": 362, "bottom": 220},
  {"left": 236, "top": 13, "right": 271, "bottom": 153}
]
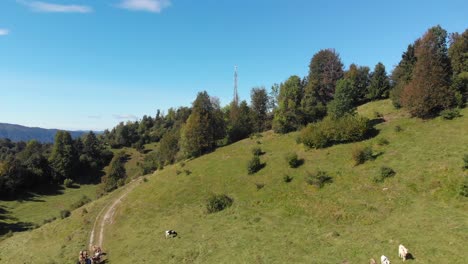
[{"left": 0, "top": 123, "right": 100, "bottom": 143}]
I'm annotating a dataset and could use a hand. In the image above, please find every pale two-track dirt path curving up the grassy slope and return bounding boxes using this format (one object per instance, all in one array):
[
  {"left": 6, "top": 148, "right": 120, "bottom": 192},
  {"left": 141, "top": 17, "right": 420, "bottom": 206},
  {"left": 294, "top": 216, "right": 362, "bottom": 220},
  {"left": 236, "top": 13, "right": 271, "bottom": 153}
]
[{"left": 89, "top": 179, "right": 141, "bottom": 249}]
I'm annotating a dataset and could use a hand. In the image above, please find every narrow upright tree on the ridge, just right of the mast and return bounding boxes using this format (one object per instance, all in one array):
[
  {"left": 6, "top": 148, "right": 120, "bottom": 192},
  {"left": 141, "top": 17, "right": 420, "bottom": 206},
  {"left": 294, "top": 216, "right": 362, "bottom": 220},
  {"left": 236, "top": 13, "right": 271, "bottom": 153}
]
[{"left": 250, "top": 87, "right": 268, "bottom": 132}]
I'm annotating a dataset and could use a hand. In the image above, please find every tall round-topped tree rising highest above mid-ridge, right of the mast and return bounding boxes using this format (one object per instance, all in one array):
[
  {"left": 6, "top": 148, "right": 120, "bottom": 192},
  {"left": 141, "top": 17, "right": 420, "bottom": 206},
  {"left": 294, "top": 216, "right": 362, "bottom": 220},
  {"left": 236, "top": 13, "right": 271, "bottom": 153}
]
[{"left": 303, "top": 49, "right": 343, "bottom": 103}]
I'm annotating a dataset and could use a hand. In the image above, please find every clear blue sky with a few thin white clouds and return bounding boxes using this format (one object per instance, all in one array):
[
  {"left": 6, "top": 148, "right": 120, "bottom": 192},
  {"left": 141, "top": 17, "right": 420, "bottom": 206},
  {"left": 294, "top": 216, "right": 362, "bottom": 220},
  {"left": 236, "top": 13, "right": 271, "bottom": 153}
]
[{"left": 0, "top": 0, "right": 468, "bottom": 130}]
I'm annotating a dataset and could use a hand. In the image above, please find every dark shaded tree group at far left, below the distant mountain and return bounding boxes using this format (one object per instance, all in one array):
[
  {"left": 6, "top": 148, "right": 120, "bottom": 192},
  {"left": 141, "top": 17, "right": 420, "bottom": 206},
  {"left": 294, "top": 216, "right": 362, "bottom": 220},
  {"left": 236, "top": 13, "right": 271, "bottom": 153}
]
[{"left": 0, "top": 131, "right": 113, "bottom": 198}]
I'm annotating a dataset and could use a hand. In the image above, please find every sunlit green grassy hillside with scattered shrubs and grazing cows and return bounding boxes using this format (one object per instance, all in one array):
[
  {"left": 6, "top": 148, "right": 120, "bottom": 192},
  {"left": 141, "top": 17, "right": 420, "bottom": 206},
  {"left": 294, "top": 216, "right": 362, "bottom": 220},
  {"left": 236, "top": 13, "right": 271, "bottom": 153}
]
[{"left": 0, "top": 101, "right": 468, "bottom": 263}]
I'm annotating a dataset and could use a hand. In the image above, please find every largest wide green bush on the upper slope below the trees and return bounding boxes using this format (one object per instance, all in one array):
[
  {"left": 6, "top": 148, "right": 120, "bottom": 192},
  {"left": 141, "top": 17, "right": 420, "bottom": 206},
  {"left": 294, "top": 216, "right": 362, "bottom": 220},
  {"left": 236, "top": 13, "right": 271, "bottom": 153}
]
[{"left": 298, "top": 114, "right": 372, "bottom": 149}]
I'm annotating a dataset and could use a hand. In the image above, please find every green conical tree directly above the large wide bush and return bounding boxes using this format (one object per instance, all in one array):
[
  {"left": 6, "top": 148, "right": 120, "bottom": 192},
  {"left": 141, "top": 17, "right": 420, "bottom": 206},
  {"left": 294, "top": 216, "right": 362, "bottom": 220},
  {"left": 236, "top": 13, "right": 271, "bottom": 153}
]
[{"left": 327, "top": 79, "right": 357, "bottom": 119}]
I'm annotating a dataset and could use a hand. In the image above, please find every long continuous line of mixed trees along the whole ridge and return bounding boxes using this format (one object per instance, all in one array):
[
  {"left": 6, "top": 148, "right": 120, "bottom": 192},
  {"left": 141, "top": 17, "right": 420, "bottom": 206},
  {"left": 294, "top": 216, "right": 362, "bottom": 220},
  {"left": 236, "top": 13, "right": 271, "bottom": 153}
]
[{"left": 0, "top": 26, "right": 468, "bottom": 198}]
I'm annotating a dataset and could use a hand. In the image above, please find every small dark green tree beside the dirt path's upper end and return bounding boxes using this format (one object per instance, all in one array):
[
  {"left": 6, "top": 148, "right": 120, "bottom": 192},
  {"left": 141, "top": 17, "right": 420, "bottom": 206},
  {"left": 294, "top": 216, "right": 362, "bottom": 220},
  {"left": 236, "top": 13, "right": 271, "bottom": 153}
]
[{"left": 102, "top": 151, "right": 127, "bottom": 192}]
